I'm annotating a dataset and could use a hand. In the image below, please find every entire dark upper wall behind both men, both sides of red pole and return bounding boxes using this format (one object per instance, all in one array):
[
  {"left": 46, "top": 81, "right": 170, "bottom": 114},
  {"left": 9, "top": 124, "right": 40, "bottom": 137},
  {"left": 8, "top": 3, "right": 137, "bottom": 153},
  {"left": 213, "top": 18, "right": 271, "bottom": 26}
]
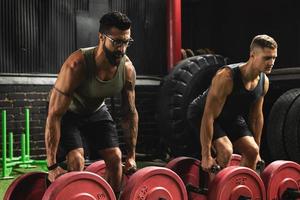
[{"left": 0, "top": 0, "right": 300, "bottom": 73}]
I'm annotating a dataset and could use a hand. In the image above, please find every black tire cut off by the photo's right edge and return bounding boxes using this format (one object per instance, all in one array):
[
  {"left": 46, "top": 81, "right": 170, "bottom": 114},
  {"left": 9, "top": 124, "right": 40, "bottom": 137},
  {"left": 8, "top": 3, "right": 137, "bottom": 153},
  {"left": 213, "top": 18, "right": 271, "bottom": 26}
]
[{"left": 267, "top": 88, "right": 300, "bottom": 163}]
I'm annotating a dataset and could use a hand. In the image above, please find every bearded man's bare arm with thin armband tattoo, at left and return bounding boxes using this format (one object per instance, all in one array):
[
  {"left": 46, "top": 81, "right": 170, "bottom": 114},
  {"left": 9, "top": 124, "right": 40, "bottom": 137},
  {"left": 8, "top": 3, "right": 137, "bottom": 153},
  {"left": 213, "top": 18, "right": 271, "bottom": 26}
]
[{"left": 45, "top": 51, "right": 84, "bottom": 166}]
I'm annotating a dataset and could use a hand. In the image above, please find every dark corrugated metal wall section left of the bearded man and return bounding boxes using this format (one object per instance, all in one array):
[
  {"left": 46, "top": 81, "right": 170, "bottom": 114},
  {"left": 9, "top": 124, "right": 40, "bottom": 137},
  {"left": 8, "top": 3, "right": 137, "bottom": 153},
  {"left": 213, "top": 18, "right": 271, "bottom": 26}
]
[{"left": 0, "top": 0, "right": 88, "bottom": 73}]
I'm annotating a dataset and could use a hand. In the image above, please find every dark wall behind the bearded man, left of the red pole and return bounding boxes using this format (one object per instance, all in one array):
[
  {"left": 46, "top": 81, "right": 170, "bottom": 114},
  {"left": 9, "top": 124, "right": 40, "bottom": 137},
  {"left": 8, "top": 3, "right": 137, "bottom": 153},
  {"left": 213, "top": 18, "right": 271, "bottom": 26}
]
[{"left": 0, "top": 0, "right": 166, "bottom": 75}]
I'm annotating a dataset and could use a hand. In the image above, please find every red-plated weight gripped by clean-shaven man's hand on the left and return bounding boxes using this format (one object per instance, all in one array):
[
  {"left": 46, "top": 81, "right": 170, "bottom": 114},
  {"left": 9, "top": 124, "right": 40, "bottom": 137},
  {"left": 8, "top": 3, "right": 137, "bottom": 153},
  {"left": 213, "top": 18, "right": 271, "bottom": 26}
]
[{"left": 166, "top": 155, "right": 265, "bottom": 200}]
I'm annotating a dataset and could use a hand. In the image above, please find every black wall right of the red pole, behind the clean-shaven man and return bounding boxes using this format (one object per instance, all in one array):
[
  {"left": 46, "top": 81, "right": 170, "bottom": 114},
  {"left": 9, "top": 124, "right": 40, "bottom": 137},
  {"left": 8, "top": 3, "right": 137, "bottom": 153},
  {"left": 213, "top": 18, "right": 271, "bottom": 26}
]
[{"left": 182, "top": 0, "right": 300, "bottom": 68}]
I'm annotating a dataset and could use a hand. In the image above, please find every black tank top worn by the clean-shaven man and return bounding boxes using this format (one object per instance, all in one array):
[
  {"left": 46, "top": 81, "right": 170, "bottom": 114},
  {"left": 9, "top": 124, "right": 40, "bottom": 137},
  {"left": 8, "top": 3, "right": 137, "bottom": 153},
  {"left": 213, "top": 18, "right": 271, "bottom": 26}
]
[{"left": 188, "top": 63, "right": 265, "bottom": 121}]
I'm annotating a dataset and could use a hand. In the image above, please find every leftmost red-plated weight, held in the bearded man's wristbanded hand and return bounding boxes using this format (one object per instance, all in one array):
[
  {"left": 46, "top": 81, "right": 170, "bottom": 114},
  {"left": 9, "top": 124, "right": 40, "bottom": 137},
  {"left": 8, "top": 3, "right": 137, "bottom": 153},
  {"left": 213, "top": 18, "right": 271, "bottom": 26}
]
[{"left": 4, "top": 171, "right": 116, "bottom": 200}]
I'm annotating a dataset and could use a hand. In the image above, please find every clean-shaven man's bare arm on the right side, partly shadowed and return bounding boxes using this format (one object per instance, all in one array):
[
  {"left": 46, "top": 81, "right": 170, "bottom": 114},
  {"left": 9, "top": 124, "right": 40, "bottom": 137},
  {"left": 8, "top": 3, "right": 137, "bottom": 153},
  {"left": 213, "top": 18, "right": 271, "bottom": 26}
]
[{"left": 249, "top": 76, "right": 269, "bottom": 146}]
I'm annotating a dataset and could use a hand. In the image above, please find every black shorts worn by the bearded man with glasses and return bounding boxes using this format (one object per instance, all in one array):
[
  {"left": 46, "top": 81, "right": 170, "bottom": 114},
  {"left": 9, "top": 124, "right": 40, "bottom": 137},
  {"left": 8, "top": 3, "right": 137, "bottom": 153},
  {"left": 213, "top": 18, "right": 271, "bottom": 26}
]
[{"left": 56, "top": 105, "right": 119, "bottom": 162}]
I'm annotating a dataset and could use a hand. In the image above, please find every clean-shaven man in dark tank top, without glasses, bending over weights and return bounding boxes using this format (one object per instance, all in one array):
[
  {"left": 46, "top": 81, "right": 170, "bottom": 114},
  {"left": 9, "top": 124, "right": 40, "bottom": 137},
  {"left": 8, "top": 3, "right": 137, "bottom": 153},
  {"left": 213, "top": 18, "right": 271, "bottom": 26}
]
[{"left": 187, "top": 35, "right": 277, "bottom": 171}]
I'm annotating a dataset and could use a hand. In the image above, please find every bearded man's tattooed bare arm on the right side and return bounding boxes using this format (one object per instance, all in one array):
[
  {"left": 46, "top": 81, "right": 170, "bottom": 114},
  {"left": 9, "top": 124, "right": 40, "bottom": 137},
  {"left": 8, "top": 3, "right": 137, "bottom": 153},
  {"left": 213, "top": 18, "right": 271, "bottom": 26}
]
[{"left": 121, "top": 61, "right": 139, "bottom": 159}]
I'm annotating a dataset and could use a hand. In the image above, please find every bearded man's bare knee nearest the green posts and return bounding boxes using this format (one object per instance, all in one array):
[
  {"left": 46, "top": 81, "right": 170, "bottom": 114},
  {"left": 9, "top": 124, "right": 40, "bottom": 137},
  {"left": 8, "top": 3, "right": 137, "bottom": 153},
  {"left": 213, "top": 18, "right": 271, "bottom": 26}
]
[{"left": 67, "top": 150, "right": 84, "bottom": 171}]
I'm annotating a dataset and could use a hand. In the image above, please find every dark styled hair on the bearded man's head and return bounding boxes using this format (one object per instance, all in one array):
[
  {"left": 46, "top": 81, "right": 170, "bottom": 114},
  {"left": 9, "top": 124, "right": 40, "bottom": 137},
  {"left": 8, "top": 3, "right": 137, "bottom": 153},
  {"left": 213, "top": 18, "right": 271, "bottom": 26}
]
[{"left": 99, "top": 11, "right": 131, "bottom": 34}]
